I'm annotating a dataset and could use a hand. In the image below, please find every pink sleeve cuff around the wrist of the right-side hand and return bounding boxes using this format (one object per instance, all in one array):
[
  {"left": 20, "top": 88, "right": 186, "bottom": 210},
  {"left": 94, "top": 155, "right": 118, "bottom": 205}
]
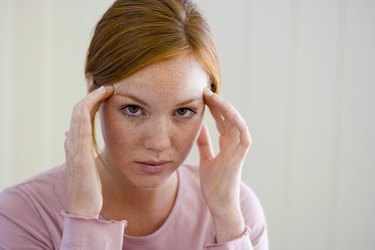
[{"left": 205, "top": 226, "right": 254, "bottom": 250}]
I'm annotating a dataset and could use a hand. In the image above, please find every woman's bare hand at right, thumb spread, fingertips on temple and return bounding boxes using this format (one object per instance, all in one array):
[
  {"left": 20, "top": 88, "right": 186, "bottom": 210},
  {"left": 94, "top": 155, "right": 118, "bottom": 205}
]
[{"left": 197, "top": 89, "right": 251, "bottom": 243}]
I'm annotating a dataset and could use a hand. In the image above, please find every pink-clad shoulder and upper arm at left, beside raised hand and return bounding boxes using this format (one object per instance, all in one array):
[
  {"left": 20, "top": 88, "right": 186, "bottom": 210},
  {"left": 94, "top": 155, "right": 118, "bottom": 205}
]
[{"left": 0, "top": 166, "right": 66, "bottom": 249}]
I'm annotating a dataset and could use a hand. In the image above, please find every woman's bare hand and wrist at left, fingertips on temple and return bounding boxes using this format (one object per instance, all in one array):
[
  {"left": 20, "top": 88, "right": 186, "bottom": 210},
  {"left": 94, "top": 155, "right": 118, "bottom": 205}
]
[{"left": 64, "top": 86, "right": 114, "bottom": 218}]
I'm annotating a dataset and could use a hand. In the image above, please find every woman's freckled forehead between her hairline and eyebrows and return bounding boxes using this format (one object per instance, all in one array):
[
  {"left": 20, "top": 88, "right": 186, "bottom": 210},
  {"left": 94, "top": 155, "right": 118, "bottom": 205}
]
[{"left": 114, "top": 56, "right": 209, "bottom": 94}]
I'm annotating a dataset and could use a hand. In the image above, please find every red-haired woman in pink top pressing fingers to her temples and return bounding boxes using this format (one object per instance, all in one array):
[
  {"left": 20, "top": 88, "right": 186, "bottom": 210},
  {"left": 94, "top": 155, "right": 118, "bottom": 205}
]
[{"left": 0, "top": 0, "right": 268, "bottom": 249}]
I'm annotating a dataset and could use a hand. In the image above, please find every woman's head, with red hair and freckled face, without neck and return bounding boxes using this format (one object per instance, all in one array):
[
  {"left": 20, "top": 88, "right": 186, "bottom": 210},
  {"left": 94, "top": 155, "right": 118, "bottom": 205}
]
[{"left": 85, "top": 0, "right": 220, "bottom": 187}]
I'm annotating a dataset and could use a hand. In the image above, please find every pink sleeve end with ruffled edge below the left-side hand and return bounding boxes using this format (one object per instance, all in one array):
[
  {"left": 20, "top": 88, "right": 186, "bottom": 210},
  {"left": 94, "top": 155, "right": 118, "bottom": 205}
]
[{"left": 61, "top": 212, "right": 127, "bottom": 250}]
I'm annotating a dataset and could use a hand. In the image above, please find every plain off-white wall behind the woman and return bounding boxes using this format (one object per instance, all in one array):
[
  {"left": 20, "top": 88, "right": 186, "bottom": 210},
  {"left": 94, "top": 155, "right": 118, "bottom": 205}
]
[{"left": 0, "top": 0, "right": 375, "bottom": 250}]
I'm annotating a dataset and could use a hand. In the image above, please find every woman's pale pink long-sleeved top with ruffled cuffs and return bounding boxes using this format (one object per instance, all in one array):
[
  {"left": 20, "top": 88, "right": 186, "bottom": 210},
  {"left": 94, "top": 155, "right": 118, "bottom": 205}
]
[{"left": 0, "top": 165, "right": 268, "bottom": 250}]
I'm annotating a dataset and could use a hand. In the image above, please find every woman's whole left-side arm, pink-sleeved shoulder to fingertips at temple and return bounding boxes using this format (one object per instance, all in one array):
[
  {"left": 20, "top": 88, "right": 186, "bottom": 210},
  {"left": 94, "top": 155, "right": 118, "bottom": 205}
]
[{"left": 0, "top": 84, "right": 122, "bottom": 249}]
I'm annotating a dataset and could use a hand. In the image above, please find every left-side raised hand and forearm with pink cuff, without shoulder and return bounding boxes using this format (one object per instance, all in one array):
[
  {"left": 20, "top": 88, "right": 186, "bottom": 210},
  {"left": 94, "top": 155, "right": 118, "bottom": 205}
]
[{"left": 61, "top": 83, "right": 126, "bottom": 249}]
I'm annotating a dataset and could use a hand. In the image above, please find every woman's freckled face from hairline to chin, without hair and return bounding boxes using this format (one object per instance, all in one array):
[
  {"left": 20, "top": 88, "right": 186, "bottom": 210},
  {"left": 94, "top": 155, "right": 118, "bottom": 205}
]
[{"left": 100, "top": 56, "right": 209, "bottom": 189}]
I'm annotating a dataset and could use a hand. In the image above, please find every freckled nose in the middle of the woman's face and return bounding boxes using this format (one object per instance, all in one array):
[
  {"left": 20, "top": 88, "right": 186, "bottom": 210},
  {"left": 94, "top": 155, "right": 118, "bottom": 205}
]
[{"left": 144, "top": 119, "right": 172, "bottom": 153}]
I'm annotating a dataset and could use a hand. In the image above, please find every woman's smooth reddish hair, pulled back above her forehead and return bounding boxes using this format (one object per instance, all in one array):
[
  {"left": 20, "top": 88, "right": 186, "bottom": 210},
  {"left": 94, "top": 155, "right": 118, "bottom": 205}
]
[{"left": 85, "top": 0, "right": 220, "bottom": 92}]
